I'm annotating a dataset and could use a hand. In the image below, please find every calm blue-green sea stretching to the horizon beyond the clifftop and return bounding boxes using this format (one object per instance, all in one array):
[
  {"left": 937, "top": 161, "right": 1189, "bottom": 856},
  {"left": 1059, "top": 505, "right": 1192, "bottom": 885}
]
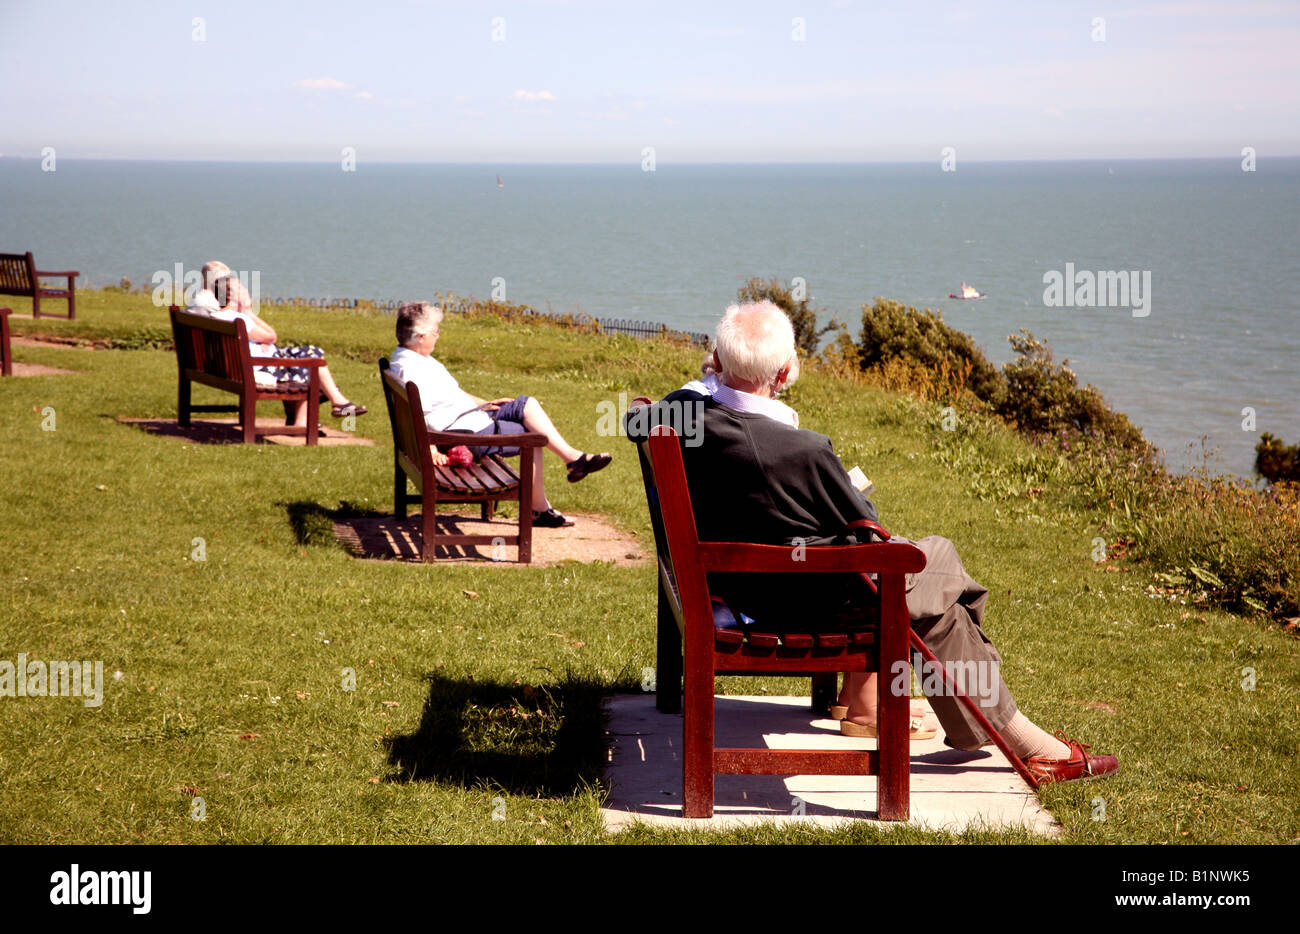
[{"left": 0, "top": 159, "right": 1300, "bottom": 474}]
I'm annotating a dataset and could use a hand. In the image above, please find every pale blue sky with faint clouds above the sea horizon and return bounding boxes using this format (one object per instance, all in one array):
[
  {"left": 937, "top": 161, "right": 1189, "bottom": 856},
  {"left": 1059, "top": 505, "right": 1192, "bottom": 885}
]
[{"left": 0, "top": 0, "right": 1300, "bottom": 164}]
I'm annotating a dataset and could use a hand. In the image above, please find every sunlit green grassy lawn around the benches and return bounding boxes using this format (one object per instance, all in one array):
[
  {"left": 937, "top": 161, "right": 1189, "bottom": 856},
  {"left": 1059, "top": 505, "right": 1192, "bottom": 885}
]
[{"left": 0, "top": 291, "right": 1300, "bottom": 843}]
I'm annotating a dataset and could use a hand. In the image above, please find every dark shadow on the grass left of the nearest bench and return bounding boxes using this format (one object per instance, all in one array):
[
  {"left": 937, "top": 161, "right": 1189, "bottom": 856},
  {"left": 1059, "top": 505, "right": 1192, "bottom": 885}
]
[{"left": 386, "top": 674, "right": 608, "bottom": 797}]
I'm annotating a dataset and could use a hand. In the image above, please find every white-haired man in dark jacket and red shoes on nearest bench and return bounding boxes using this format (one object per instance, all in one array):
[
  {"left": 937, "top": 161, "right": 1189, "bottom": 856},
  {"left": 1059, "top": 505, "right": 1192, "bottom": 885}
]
[{"left": 629, "top": 302, "right": 1119, "bottom": 782}]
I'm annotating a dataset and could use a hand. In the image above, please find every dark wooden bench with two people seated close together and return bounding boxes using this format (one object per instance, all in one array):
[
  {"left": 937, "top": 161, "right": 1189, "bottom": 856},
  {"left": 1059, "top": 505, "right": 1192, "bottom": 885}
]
[{"left": 172, "top": 304, "right": 325, "bottom": 445}]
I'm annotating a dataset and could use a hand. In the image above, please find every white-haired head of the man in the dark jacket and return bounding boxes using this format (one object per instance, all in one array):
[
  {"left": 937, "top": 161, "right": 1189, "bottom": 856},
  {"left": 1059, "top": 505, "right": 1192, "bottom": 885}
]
[{"left": 714, "top": 302, "right": 800, "bottom": 395}]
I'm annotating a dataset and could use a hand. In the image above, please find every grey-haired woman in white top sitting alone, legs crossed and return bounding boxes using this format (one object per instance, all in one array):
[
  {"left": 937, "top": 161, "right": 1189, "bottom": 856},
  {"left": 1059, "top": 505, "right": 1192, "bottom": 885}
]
[{"left": 389, "top": 302, "right": 612, "bottom": 528}]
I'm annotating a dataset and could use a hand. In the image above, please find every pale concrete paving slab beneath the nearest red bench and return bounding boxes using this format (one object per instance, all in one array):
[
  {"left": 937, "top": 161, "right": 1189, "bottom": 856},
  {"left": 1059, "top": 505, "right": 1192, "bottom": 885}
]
[{"left": 601, "top": 693, "right": 1061, "bottom": 838}]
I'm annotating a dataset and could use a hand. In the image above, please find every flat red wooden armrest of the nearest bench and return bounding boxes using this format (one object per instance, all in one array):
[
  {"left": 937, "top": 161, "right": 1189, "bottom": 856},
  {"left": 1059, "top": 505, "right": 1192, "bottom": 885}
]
[{"left": 699, "top": 541, "right": 926, "bottom": 574}]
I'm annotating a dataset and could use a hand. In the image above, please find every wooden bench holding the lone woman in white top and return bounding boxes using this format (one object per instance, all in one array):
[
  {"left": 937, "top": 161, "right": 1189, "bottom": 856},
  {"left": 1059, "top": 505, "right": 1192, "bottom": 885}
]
[{"left": 380, "top": 358, "right": 546, "bottom": 565}]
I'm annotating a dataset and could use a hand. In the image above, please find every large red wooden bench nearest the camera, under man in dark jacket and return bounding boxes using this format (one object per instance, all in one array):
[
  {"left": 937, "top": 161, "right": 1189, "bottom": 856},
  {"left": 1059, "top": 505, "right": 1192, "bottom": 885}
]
[{"left": 638, "top": 427, "right": 926, "bottom": 821}]
